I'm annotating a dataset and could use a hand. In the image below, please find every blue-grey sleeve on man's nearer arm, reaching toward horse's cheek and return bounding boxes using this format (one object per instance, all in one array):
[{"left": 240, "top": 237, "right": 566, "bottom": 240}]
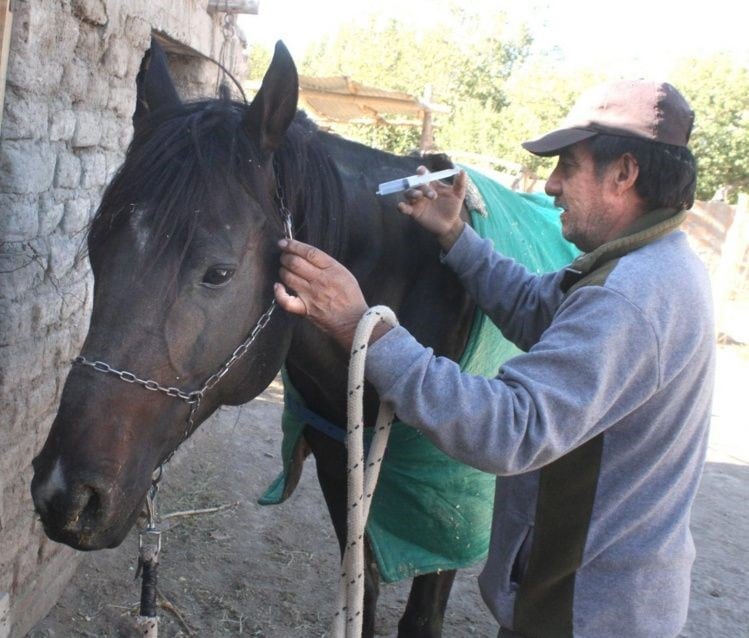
[{"left": 366, "top": 286, "right": 659, "bottom": 475}]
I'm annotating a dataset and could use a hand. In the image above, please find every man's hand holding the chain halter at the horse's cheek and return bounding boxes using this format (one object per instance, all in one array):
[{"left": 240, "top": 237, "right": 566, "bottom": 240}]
[{"left": 274, "top": 239, "right": 387, "bottom": 350}]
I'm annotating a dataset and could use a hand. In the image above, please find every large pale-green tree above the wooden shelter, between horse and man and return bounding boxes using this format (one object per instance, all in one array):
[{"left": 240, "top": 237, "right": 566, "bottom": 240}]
[{"left": 301, "top": 4, "right": 531, "bottom": 154}]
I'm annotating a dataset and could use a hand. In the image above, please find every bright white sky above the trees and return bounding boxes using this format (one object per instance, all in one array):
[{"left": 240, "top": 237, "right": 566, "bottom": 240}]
[{"left": 240, "top": 0, "right": 749, "bottom": 79}]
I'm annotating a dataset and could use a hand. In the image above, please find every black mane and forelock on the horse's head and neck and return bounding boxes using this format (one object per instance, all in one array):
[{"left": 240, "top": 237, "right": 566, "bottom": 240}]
[{"left": 88, "top": 98, "right": 344, "bottom": 268}]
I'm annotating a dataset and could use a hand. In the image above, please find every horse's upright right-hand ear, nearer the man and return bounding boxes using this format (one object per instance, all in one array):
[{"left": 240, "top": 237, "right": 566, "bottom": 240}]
[{"left": 244, "top": 40, "right": 299, "bottom": 153}]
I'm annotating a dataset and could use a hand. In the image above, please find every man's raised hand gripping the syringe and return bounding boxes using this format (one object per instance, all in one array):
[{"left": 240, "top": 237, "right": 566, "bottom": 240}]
[{"left": 398, "top": 166, "right": 466, "bottom": 252}]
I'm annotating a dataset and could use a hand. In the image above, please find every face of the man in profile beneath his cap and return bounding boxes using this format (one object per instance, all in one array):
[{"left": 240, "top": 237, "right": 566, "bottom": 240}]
[{"left": 546, "top": 142, "right": 623, "bottom": 252}]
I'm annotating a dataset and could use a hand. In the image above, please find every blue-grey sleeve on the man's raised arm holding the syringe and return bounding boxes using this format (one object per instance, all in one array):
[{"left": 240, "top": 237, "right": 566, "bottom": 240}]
[{"left": 443, "top": 225, "right": 563, "bottom": 350}]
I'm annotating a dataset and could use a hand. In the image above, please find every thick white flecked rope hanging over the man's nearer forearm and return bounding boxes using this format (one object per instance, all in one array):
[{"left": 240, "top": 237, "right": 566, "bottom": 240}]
[{"left": 331, "top": 306, "right": 398, "bottom": 638}]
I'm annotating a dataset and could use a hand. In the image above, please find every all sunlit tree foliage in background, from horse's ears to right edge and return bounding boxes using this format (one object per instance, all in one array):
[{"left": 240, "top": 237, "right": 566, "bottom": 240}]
[{"left": 249, "top": 16, "right": 749, "bottom": 201}]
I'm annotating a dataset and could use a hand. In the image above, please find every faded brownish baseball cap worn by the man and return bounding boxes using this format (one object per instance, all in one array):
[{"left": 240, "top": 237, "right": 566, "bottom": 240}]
[{"left": 523, "top": 80, "right": 694, "bottom": 157}]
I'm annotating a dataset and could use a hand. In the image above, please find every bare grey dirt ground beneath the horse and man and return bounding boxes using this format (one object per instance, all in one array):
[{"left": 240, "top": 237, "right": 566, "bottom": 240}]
[{"left": 29, "top": 347, "right": 749, "bottom": 638}]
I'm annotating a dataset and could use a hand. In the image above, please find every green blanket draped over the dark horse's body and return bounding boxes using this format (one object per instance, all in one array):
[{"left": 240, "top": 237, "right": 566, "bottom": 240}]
[{"left": 260, "top": 168, "right": 578, "bottom": 582}]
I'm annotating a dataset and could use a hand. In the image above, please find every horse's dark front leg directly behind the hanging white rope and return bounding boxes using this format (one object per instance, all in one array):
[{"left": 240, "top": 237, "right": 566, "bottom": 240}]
[{"left": 304, "top": 427, "right": 380, "bottom": 638}]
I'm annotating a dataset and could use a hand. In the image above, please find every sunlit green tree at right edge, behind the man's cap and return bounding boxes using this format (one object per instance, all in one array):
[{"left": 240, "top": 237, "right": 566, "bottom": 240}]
[{"left": 673, "top": 54, "right": 749, "bottom": 203}]
